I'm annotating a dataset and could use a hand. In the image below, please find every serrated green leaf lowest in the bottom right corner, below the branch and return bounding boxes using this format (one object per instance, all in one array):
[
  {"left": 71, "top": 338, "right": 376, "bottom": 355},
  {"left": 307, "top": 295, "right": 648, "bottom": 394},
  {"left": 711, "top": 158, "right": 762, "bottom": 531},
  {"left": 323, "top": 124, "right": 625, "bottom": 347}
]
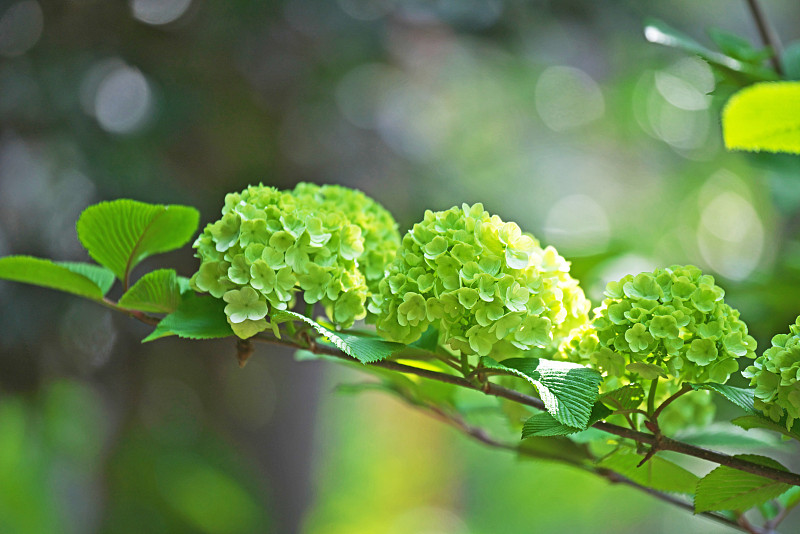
[{"left": 694, "top": 454, "right": 792, "bottom": 514}]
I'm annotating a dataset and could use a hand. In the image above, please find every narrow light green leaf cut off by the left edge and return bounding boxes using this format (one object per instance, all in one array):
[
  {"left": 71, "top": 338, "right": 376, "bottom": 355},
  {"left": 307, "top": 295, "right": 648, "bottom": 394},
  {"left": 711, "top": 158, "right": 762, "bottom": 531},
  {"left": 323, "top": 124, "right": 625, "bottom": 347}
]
[{"left": 0, "top": 256, "right": 103, "bottom": 300}]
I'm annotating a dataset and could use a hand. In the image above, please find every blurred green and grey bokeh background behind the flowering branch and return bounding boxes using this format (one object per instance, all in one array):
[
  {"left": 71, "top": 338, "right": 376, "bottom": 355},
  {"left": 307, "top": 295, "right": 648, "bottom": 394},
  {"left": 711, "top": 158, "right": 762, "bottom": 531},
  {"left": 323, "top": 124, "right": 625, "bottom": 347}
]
[{"left": 0, "top": 0, "right": 800, "bottom": 534}]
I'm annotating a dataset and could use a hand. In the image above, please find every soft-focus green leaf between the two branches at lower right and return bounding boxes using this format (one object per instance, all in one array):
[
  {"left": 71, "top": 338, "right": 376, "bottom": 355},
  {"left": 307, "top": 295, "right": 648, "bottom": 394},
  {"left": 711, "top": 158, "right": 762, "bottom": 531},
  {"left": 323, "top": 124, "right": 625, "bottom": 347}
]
[{"left": 597, "top": 447, "right": 699, "bottom": 493}]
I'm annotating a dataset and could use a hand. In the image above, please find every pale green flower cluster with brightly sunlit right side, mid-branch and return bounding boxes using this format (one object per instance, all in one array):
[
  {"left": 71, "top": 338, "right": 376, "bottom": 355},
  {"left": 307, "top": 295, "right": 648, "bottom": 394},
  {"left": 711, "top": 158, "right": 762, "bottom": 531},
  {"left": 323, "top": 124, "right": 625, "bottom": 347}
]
[{"left": 370, "top": 204, "right": 589, "bottom": 358}]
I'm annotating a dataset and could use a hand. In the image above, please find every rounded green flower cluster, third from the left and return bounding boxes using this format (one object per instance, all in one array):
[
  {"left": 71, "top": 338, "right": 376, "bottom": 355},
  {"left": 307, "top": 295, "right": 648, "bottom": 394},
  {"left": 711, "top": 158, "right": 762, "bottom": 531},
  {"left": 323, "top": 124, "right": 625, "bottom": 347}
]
[{"left": 560, "top": 265, "right": 756, "bottom": 384}]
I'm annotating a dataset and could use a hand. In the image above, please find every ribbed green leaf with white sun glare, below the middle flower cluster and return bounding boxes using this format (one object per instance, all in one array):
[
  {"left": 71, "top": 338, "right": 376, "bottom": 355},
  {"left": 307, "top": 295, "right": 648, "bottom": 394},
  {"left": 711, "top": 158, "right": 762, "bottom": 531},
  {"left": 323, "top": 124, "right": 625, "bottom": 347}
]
[{"left": 480, "top": 356, "right": 602, "bottom": 430}]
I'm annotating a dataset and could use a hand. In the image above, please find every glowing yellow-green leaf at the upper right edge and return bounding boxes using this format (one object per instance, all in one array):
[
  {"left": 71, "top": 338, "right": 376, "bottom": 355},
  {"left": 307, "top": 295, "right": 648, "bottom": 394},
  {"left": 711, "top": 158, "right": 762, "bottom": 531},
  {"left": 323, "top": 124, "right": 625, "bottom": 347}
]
[{"left": 722, "top": 82, "right": 800, "bottom": 154}]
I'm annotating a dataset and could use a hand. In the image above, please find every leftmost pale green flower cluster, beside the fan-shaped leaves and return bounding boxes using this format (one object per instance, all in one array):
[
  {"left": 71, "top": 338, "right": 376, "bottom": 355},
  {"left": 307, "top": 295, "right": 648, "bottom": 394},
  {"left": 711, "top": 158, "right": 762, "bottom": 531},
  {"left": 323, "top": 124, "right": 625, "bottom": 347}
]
[{"left": 191, "top": 184, "right": 399, "bottom": 338}]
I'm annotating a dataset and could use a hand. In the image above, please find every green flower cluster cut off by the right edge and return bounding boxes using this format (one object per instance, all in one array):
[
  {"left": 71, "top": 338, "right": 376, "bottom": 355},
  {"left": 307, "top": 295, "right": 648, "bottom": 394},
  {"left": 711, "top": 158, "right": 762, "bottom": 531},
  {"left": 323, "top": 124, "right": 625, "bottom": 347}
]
[{"left": 742, "top": 317, "right": 800, "bottom": 430}]
